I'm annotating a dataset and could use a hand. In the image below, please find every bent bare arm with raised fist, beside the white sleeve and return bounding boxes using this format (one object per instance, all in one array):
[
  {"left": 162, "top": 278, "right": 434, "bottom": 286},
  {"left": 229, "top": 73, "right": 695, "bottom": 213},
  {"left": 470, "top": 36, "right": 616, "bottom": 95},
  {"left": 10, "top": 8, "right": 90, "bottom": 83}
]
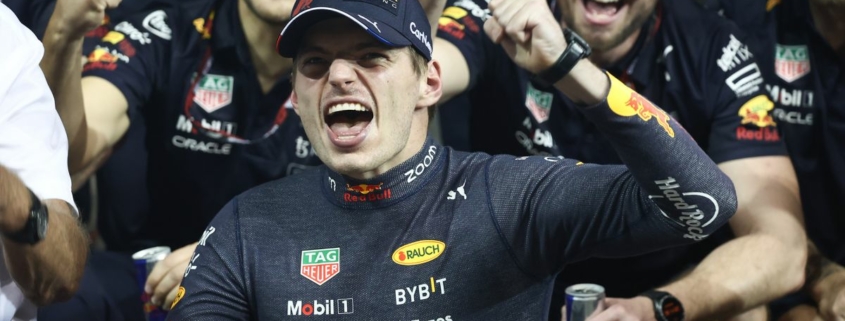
[{"left": 41, "top": 0, "right": 129, "bottom": 185}]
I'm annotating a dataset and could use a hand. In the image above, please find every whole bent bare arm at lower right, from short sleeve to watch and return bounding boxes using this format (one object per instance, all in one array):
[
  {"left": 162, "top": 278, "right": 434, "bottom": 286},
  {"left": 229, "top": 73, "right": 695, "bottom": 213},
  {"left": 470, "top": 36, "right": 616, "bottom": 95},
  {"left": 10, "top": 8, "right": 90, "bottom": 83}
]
[{"left": 662, "top": 156, "right": 807, "bottom": 320}]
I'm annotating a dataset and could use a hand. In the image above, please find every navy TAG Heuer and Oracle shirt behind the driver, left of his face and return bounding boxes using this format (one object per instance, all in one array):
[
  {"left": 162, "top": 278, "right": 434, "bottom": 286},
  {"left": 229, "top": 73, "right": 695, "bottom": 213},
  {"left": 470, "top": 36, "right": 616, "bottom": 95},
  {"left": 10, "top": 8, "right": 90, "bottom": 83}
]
[{"left": 83, "top": 0, "right": 319, "bottom": 251}]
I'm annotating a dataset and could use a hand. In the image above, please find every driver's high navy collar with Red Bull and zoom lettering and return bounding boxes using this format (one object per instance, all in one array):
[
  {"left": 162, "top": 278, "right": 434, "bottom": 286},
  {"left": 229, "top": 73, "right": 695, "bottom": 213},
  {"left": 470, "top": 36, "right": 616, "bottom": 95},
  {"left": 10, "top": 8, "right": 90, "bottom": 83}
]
[{"left": 323, "top": 139, "right": 445, "bottom": 209}]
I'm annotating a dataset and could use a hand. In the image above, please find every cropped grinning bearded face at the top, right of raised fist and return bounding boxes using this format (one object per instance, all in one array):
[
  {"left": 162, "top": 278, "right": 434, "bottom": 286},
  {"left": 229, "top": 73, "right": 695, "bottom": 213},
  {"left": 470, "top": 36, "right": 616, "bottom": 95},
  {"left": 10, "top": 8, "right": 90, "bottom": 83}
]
[{"left": 557, "top": 0, "right": 656, "bottom": 51}]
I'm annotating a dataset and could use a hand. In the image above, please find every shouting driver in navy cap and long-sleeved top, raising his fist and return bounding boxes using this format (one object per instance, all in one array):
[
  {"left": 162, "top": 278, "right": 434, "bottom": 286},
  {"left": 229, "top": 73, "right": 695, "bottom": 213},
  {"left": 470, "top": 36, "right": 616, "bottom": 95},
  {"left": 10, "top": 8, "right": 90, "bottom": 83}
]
[{"left": 170, "top": 0, "right": 735, "bottom": 320}]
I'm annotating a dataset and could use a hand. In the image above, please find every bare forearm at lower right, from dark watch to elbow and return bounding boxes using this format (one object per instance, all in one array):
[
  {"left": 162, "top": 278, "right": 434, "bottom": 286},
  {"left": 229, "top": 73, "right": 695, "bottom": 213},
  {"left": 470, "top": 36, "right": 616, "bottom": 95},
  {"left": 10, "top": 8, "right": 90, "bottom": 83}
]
[{"left": 662, "top": 226, "right": 804, "bottom": 320}]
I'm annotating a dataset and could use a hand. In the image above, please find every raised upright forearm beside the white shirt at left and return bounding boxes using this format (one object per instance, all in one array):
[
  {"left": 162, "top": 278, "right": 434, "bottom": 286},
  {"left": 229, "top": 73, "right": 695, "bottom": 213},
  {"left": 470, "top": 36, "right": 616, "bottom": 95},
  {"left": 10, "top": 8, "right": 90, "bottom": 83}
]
[{"left": 41, "top": 13, "right": 93, "bottom": 173}]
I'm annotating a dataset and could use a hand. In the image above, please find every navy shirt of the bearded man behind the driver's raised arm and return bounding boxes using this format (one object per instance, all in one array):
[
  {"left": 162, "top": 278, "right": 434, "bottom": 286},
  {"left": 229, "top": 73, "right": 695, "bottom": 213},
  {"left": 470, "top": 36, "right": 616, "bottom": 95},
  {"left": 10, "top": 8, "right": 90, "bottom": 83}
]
[{"left": 438, "top": 0, "right": 786, "bottom": 320}]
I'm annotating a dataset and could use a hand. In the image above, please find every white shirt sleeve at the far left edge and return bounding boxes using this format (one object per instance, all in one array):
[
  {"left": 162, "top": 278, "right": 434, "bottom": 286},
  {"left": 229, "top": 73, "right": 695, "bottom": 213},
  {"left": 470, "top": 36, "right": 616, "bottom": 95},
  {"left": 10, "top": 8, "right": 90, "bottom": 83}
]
[{"left": 0, "top": 3, "right": 76, "bottom": 214}]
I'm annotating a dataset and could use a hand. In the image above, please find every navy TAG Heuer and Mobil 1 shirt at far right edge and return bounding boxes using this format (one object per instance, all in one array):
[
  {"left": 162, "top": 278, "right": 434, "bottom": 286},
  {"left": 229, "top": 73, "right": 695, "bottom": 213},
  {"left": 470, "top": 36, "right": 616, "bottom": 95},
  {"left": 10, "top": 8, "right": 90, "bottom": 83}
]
[{"left": 710, "top": 0, "right": 845, "bottom": 264}]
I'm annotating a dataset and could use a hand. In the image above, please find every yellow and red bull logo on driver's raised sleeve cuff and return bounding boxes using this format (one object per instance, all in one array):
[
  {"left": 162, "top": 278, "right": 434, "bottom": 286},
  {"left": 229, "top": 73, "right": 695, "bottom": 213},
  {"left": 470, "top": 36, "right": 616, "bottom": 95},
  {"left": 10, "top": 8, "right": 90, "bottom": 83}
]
[{"left": 607, "top": 74, "right": 675, "bottom": 137}]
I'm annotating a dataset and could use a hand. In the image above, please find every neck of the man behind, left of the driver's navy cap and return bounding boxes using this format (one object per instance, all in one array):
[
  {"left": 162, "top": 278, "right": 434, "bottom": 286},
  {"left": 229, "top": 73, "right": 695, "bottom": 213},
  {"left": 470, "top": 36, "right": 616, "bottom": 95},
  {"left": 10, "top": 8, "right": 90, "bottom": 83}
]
[{"left": 238, "top": 0, "right": 293, "bottom": 93}]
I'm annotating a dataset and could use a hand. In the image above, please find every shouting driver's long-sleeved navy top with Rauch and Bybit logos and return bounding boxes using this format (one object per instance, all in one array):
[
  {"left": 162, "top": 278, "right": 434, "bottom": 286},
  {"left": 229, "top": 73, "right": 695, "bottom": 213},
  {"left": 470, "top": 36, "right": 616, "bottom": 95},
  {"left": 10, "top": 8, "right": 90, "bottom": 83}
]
[{"left": 168, "top": 82, "right": 736, "bottom": 321}]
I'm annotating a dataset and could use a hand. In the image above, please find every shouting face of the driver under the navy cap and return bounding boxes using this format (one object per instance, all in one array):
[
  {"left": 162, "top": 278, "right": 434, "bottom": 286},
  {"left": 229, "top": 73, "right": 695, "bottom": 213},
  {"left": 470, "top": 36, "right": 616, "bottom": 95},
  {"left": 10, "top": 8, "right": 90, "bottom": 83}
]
[{"left": 291, "top": 18, "right": 440, "bottom": 178}]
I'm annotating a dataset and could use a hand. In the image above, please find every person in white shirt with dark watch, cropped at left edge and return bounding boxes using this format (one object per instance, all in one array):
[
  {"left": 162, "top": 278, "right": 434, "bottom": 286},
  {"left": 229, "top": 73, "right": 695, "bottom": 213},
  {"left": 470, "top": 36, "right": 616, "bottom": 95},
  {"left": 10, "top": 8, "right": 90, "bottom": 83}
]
[{"left": 0, "top": 3, "right": 88, "bottom": 321}]
